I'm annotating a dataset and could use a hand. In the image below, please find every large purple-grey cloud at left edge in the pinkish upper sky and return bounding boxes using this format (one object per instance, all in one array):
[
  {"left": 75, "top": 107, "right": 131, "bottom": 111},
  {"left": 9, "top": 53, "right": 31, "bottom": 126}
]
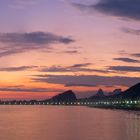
[{"left": 0, "top": 32, "right": 74, "bottom": 57}]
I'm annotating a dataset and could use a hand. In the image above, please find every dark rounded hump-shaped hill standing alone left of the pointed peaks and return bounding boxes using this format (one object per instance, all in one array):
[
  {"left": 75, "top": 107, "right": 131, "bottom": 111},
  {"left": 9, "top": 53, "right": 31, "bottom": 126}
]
[{"left": 50, "top": 90, "right": 77, "bottom": 102}]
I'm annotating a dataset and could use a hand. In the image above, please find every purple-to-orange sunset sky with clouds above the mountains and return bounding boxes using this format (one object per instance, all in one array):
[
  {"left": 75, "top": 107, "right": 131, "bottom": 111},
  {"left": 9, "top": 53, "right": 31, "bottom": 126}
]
[{"left": 0, "top": 0, "right": 140, "bottom": 100}]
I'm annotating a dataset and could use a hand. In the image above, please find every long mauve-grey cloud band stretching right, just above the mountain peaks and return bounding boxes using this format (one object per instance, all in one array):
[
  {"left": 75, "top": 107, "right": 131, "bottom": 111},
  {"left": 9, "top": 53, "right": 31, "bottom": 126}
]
[{"left": 32, "top": 75, "right": 140, "bottom": 87}]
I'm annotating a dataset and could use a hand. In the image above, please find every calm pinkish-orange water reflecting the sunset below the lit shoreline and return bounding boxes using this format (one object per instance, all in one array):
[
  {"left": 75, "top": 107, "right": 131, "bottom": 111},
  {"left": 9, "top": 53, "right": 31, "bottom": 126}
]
[{"left": 0, "top": 106, "right": 140, "bottom": 140}]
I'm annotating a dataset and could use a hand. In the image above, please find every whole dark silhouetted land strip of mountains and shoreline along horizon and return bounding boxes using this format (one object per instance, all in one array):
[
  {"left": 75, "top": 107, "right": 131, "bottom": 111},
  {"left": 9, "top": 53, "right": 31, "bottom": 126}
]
[{"left": 0, "top": 83, "right": 140, "bottom": 109}]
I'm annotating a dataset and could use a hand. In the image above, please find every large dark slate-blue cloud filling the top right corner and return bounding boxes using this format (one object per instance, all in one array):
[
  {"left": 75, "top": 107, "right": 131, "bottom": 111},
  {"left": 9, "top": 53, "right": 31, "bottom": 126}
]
[{"left": 72, "top": 0, "right": 140, "bottom": 20}]
